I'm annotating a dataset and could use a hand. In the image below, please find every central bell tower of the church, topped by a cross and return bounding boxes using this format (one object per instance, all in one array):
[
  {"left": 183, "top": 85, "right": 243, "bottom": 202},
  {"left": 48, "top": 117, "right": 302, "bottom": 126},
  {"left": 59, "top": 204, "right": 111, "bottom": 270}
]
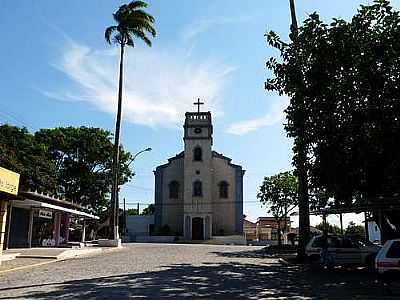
[{"left": 183, "top": 99, "right": 213, "bottom": 240}]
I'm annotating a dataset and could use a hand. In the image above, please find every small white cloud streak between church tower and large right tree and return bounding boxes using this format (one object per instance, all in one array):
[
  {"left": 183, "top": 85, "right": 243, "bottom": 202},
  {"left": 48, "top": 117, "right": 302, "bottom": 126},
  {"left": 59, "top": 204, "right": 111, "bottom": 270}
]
[{"left": 227, "top": 97, "right": 289, "bottom": 135}]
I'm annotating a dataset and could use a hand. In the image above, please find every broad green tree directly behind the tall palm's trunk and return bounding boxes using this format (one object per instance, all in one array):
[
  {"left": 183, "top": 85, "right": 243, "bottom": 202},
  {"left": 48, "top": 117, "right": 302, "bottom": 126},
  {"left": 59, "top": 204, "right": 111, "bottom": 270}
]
[{"left": 35, "top": 127, "right": 134, "bottom": 215}]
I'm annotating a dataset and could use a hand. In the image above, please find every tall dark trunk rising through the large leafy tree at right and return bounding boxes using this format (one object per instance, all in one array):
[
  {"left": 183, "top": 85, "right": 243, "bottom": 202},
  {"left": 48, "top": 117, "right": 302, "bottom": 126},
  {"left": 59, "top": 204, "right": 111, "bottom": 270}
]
[{"left": 289, "top": 0, "right": 310, "bottom": 261}]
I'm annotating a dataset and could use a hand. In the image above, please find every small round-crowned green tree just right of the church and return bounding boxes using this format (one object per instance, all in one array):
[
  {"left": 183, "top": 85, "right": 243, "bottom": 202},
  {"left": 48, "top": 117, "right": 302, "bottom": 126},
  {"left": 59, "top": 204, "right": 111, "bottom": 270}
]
[{"left": 257, "top": 172, "right": 299, "bottom": 247}]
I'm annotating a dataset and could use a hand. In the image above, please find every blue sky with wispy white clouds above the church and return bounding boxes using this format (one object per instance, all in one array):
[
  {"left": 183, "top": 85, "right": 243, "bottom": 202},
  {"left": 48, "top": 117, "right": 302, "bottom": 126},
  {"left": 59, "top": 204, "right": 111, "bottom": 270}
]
[{"left": 0, "top": 0, "right": 399, "bottom": 224}]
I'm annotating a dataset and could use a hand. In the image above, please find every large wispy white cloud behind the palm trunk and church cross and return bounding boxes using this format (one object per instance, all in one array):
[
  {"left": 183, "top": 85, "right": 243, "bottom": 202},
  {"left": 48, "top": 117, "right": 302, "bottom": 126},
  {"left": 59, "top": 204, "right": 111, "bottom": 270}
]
[{"left": 42, "top": 41, "right": 234, "bottom": 127}]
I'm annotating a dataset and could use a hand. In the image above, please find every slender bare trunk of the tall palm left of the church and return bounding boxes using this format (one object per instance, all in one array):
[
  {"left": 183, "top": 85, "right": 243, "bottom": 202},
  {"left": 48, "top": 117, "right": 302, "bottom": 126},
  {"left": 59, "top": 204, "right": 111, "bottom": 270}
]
[{"left": 110, "top": 42, "right": 125, "bottom": 240}]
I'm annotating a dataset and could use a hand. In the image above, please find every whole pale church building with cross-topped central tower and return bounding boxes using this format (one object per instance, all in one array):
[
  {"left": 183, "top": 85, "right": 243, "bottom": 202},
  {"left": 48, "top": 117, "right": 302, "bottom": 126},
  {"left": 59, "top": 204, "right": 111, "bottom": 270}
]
[{"left": 154, "top": 101, "right": 245, "bottom": 240}]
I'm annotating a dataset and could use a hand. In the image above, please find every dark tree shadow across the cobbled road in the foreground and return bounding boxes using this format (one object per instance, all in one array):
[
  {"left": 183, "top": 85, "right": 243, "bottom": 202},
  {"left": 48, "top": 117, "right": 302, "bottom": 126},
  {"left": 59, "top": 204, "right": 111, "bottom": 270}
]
[{"left": 0, "top": 262, "right": 399, "bottom": 300}]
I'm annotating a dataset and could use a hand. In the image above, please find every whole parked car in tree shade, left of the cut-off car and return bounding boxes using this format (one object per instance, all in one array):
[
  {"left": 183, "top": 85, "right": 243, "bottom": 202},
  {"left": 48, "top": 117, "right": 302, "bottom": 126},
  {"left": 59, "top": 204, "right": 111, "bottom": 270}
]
[{"left": 306, "top": 235, "right": 381, "bottom": 268}]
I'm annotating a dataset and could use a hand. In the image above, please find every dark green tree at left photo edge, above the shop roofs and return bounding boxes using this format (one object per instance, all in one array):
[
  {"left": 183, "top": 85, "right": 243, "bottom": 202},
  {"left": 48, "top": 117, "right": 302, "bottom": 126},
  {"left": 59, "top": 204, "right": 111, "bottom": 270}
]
[{"left": 0, "top": 125, "right": 57, "bottom": 193}]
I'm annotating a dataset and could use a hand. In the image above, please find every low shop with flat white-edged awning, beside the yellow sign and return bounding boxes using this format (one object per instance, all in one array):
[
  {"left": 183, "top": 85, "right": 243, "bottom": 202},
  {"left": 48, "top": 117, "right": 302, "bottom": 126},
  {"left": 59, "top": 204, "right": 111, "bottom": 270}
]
[{"left": 4, "top": 191, "right": 98, "bottom": 249}]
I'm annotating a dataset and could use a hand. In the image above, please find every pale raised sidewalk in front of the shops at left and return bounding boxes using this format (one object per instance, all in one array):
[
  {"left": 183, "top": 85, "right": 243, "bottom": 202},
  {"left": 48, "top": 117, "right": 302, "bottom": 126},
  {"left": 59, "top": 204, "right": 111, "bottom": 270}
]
[{"left": 0, "top": 247, "right": 105, "bottom": 274}]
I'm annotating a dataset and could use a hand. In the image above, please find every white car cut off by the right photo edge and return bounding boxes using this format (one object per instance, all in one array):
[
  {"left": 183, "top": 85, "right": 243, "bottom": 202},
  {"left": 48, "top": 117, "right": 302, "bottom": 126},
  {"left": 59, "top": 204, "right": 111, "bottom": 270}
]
[{"left": 375, "top": 239, "right": 400, "bottom": 278}]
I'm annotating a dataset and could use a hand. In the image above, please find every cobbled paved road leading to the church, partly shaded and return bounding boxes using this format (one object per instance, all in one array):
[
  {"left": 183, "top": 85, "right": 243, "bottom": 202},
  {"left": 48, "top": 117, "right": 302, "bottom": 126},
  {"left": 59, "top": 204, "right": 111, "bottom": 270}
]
[{"left": 0, "top": 244, "right": 399, "bottom": 300}]
